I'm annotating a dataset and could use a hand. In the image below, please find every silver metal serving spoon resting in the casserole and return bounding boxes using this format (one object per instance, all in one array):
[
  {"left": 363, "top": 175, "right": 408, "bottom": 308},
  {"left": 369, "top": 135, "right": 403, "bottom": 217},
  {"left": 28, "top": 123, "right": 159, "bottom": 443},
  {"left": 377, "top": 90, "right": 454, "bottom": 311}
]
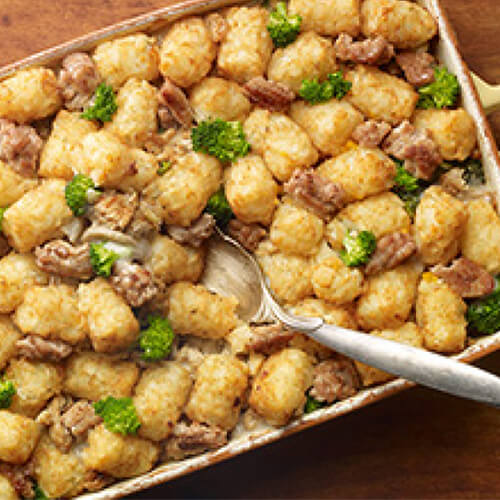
[{"left": 202, "top": 228, "right": 500, "bottom": 407}]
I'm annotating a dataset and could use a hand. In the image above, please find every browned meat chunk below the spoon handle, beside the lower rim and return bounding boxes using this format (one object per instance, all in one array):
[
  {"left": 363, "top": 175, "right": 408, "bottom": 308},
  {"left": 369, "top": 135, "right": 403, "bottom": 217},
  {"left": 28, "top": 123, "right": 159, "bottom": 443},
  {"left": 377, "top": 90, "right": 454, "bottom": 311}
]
[{"left": 309, "top": 356, "right": 360, "bottom": 403}]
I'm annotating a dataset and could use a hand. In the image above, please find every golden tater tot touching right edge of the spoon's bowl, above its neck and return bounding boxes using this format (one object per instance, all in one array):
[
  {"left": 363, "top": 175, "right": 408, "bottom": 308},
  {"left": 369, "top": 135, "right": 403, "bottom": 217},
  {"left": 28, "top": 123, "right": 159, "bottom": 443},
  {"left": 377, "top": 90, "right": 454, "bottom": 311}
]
[{"left": 256, "top": 241, "right": 313, "bottom": 304}]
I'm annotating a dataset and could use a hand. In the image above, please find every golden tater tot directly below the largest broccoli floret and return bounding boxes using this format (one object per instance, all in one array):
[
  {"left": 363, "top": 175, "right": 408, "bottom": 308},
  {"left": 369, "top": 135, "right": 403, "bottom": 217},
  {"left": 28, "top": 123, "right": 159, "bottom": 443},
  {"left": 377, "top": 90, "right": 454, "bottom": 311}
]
[{"left": 143, "top": 152, "right": 222, "bottom": 227}]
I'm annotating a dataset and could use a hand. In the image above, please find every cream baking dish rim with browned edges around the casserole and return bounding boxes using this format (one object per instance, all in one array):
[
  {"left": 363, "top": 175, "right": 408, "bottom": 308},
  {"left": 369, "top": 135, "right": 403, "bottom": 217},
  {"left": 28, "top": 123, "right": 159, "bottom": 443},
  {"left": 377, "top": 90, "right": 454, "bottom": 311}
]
[{"left": 0, "top": 0, "right": 500, "bottom": 500}]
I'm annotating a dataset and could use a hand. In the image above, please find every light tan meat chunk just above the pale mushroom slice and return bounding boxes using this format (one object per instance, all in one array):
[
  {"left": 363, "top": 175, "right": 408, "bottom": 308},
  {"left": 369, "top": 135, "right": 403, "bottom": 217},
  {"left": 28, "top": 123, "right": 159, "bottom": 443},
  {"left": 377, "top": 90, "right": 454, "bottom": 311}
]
[{"left": 90, "top": 191, "right": 139, "bottom": 231}]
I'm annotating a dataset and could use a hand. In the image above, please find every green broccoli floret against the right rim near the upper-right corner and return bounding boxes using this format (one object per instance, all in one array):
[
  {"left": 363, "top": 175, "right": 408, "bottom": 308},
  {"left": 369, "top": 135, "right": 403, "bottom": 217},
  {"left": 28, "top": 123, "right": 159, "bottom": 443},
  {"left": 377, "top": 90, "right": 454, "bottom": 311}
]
[{"left": 417, "top": 66, "right": 460, "bottom": 109}]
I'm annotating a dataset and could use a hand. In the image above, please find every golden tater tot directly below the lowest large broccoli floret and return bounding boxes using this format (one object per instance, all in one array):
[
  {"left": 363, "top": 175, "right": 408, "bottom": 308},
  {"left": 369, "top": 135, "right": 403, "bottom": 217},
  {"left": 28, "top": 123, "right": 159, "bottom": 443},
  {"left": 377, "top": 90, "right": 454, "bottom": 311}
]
[{"left": 82, "top": 424, "right": 160, "bottom": 478}]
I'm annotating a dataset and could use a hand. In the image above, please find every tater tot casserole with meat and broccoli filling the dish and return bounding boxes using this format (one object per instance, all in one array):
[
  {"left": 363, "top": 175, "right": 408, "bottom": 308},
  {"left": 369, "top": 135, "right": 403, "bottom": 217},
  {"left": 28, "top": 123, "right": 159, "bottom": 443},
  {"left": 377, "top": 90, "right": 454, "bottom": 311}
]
[{"left": 0, "top": 0, "right": 494, "bottom": 499}]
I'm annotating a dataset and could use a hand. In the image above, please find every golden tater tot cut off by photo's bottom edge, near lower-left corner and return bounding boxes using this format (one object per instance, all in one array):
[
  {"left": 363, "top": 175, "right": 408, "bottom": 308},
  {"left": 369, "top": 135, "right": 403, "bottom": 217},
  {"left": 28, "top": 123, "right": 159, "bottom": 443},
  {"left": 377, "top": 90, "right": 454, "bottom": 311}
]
[{"left": 33, "top": 434, "right": 89, "bottom": 498}]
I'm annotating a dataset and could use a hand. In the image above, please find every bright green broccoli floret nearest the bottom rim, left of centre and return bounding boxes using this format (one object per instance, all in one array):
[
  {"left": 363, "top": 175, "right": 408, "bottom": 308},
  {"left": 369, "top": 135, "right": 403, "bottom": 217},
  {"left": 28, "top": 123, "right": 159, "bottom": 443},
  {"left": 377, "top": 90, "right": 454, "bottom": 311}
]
[{"left": 94, "top": 396, "right": 141, "bottom": 434}]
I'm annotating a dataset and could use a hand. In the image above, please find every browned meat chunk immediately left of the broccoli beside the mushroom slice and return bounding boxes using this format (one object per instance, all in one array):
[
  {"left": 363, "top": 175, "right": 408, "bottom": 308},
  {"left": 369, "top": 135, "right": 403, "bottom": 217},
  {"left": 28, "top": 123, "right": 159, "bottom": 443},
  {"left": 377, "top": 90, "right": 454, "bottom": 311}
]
[{"left": 35, "top": 240, "right": 94, "bottom": 279}]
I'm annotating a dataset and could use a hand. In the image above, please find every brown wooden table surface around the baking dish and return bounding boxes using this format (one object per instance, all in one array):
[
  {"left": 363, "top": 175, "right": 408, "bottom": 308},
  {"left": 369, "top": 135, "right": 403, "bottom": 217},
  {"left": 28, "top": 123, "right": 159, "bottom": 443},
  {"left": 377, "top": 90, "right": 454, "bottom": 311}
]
[{"left": 0, "top": 0, "right": 500, "bottom": 499}]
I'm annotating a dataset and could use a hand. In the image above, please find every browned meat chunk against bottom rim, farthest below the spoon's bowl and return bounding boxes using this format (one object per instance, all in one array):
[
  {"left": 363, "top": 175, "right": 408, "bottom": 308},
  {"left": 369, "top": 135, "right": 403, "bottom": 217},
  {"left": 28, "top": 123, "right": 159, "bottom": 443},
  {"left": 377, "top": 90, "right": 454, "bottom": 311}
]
[{"left": 166, "top": 422, "right": 227, "bottom": 460}]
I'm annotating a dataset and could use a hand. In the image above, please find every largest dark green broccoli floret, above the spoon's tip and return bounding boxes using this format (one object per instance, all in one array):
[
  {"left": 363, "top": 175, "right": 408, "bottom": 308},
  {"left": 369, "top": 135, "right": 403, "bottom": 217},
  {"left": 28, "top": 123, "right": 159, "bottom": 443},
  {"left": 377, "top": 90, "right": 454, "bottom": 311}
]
[{"left": 191, "top": 118, "right": 250, "bottom": 162}]
